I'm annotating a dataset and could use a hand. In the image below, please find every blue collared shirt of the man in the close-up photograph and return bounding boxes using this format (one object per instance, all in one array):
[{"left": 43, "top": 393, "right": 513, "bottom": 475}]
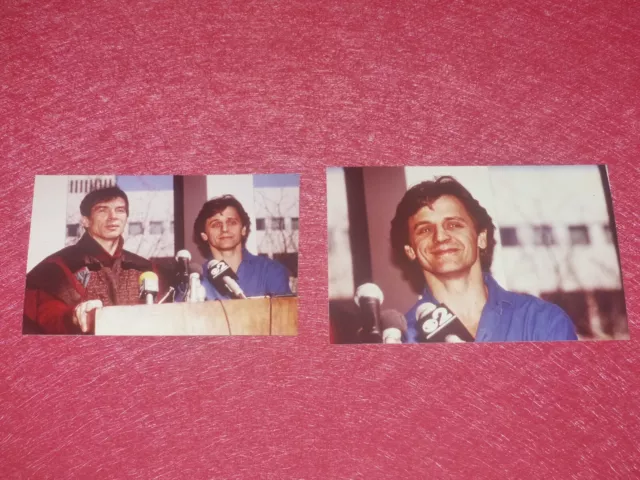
[{"left": 404, "top": 273, "right": 578, "bottom": 343}]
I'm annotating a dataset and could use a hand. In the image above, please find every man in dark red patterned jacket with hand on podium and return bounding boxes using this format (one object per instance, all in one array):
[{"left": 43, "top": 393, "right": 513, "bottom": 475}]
[{"left": 23, "top": 187, "right": 152, "bottom": 334}]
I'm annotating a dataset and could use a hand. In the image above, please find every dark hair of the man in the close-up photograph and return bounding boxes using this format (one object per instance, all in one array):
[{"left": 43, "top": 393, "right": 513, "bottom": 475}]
[{"left": 391, "top": 176, "right": 496, "bottom": 272}]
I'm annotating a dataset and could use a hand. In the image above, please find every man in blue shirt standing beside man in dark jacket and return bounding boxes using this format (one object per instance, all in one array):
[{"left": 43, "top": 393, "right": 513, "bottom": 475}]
[{"left": 193, "top": 195, "right": 291, "bottom": 300}]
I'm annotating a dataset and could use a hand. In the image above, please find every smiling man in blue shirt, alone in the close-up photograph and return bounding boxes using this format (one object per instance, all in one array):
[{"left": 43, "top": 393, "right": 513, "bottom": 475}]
[{"left": 391, "top": 177, "right": 577, "bottom": 343}]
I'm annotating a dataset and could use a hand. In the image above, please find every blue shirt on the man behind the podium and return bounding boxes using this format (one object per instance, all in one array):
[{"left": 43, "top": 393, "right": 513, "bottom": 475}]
[{"left": 202, "top": 249, "right": 291, "bottom": 300}]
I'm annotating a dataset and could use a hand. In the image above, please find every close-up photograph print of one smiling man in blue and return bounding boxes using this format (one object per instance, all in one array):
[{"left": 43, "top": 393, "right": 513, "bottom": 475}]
[{"left": 327, "top": 165, "right": 629, "bottom": 344}]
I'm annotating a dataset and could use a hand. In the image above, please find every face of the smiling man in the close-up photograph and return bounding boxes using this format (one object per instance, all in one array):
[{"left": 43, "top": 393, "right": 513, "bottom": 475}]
[{"left": 404, "top": 195, "right": 487, "bottom": 276}]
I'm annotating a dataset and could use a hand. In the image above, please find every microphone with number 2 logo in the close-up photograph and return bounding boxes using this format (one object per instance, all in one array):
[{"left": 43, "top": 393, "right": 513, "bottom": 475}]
[{"left": 416, "top": 302, "right": 475, "bottom": 343}]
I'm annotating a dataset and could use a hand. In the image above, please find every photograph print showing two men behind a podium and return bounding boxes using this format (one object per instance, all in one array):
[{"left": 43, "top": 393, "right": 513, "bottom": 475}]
[{"left": 22, "top": 174, "right": 300, "bottom": 335}]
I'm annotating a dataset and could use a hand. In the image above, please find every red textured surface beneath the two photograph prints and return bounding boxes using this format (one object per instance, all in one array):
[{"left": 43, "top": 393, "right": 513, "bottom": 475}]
[{"left": 0, "top": 0, "right": 640, "bottom": 479}]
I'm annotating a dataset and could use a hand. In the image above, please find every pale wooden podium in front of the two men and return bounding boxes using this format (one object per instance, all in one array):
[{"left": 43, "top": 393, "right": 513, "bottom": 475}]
[{"left": 95, "top": 297, "right": 298, "bottom": 335}]
